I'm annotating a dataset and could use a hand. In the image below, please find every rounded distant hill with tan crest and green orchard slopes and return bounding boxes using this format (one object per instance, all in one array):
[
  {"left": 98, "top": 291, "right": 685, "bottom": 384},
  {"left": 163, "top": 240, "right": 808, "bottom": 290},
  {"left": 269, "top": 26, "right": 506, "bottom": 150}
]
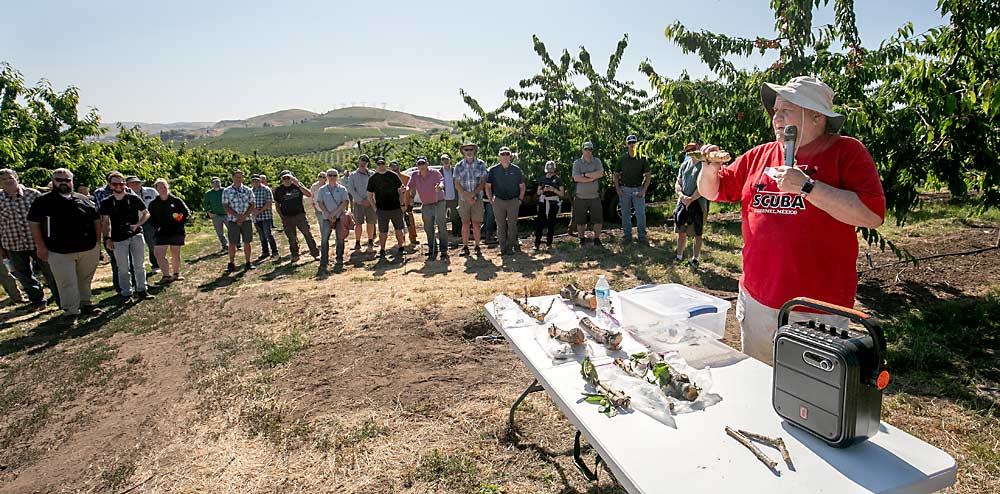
[{"left": 192, "top": 107, "right": 452, "bottom": 156}]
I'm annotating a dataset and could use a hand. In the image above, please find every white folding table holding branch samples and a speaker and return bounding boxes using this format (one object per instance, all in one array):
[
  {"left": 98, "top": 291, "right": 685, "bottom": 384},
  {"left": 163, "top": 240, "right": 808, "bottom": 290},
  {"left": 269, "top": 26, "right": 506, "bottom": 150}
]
[{"left": 486, "top": 296, "right": 957, "bottom": 494}]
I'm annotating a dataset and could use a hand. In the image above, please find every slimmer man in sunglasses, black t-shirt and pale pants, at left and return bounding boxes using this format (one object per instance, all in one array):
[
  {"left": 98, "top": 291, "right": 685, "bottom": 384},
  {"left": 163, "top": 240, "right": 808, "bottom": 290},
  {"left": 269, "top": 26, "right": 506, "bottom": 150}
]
[{"left": 99, "top": 172, "right": 150, "bottom": 303}]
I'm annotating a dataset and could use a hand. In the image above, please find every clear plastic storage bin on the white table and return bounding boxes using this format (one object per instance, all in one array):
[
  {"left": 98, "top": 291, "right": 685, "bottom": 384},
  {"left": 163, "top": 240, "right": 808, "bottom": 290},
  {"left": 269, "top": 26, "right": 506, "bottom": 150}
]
[{"left": 618, "top": 283, "right": 732, "bottom": 338}]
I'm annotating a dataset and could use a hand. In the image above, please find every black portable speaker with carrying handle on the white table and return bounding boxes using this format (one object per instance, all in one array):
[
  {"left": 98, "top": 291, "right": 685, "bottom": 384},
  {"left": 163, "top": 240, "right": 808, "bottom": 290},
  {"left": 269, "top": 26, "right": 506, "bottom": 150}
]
[{"left": 771, "top": 298, "right": 889, "bottom": 448}]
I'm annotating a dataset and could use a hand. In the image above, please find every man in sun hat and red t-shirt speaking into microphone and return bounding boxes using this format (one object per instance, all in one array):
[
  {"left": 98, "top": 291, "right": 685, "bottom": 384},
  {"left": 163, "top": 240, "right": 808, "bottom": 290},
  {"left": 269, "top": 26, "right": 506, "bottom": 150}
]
[{"left": 698, "top": 77, "right": 885, "bottom": 363}]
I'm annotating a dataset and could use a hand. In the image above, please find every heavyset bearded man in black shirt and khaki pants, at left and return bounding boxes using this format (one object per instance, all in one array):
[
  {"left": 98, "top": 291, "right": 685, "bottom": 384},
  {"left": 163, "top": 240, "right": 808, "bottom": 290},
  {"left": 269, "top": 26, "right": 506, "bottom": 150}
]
[{"left": 28, "top": 168, "right": 101, "bottom": 325}]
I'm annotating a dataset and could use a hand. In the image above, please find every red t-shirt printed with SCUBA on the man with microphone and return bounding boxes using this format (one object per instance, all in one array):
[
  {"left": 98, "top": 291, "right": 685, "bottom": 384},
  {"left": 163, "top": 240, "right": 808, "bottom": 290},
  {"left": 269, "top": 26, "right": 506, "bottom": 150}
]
[{"left": 718, "top": 135, "right": 885, "bottom": 309}]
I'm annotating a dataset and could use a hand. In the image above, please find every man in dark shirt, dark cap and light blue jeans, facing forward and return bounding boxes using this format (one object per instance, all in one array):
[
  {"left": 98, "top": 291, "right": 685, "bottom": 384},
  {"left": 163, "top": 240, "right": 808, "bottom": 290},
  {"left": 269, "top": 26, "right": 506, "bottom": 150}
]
[{"left": 614, "top": 135, "right": 651, "bottom": 244}]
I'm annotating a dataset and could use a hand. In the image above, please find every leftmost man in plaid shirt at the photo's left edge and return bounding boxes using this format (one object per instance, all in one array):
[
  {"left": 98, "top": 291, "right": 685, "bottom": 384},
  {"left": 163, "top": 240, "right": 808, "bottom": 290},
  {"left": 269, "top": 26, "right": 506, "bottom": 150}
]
[{"left": 0, "top": 168, "right": 59, "bottom": 308}]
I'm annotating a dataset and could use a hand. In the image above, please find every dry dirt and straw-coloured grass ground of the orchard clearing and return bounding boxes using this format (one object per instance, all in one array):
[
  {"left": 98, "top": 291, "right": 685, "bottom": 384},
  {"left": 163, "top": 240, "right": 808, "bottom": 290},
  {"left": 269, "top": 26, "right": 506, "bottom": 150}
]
[{"left": 0, "top": 206, "right": 1000, "bottom": 493}]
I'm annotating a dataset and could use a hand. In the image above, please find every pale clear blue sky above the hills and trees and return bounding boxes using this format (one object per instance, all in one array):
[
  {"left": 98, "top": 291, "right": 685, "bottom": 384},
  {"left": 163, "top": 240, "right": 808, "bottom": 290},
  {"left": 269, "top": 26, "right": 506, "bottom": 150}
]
[{"left": 0, "top": 0, "right": 942, "bottom": 122}]
